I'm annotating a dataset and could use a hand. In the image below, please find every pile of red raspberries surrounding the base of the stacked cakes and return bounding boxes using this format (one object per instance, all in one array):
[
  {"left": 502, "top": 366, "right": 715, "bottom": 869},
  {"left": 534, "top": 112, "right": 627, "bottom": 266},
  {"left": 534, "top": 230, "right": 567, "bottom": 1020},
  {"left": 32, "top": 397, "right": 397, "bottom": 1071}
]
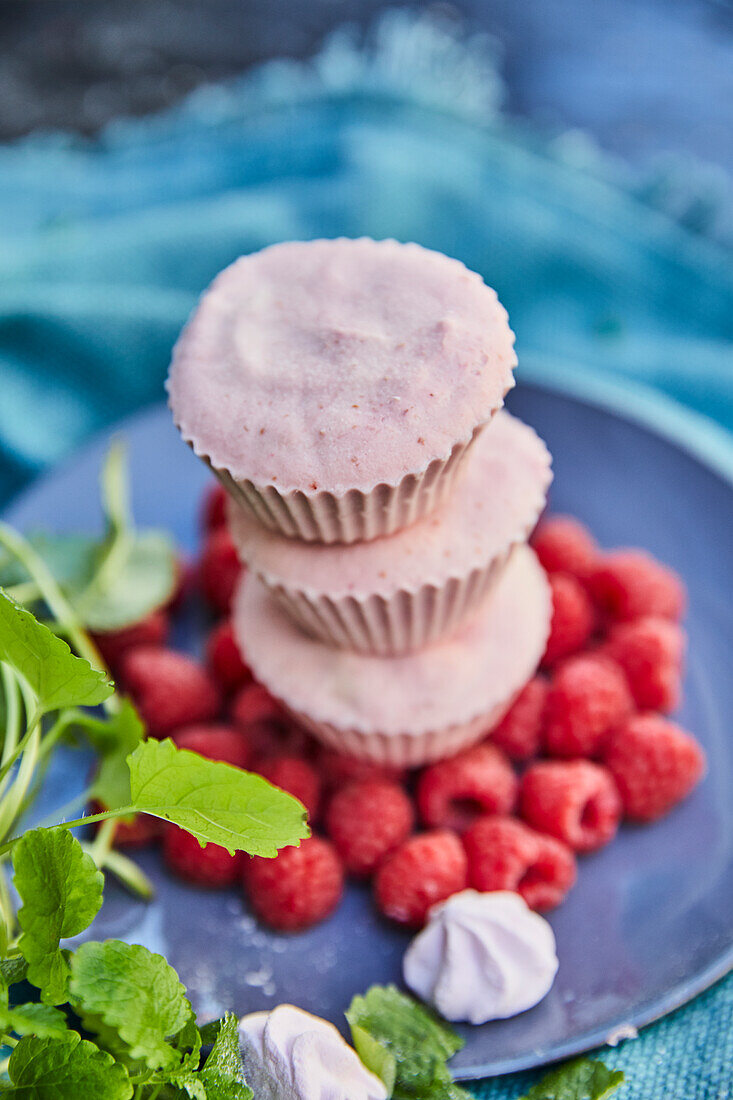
[{"left": 91, "top": 487, "right": 705, "bottom": 931}]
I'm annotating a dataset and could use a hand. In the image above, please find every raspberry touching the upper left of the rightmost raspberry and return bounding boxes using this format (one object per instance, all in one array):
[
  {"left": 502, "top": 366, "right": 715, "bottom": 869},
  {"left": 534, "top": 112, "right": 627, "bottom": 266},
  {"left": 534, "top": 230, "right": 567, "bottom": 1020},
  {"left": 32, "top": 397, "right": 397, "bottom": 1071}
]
[{"left": 545, "top": 653, "right": 632, "bottom": 758}]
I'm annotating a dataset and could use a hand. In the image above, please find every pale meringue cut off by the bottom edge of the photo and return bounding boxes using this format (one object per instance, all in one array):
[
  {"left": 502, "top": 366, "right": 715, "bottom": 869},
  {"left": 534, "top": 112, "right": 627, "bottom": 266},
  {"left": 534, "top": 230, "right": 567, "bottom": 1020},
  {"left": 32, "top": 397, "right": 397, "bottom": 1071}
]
[{"left": 239, "top": 1004, "right": 387, "bottom": 1100}]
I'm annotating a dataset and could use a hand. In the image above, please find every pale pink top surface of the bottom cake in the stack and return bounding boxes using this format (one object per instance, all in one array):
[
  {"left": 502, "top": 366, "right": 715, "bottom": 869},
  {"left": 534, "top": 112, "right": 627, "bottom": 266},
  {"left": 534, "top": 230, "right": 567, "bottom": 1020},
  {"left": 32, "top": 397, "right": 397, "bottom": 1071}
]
[{"left": 233, "top": 546, "right": 550, "bottom": 735}]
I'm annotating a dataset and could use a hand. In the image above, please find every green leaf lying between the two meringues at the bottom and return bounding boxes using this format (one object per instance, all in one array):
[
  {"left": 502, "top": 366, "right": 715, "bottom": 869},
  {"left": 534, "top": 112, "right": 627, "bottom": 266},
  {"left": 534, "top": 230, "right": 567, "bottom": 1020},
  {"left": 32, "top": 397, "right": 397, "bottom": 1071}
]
[{"left": 346, "top": 986, "right": 463, "bottom": 1100}]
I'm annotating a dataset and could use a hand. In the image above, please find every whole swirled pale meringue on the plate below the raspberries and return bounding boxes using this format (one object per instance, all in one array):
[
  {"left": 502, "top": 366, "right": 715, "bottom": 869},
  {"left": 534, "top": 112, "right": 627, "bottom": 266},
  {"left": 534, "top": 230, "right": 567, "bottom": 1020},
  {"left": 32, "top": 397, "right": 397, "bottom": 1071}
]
[{"left": 403, "top": 890, "right": 558, "bottom": 1024}]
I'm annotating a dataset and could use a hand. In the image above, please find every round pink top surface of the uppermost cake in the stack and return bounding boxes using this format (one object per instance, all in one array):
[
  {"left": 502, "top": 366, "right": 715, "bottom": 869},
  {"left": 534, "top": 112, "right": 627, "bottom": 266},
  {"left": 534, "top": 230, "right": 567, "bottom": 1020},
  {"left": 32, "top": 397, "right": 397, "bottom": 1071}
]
[{"left": 168, "top": 239, "right": 516, "bottom": 494}]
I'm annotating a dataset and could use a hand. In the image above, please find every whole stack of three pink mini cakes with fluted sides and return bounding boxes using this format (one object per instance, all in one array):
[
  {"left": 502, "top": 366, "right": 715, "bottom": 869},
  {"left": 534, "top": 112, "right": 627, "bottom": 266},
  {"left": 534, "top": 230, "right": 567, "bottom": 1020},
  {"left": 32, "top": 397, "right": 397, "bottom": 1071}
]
[{"left": 168, "top": 239, "right": 550, "bottom": 766}]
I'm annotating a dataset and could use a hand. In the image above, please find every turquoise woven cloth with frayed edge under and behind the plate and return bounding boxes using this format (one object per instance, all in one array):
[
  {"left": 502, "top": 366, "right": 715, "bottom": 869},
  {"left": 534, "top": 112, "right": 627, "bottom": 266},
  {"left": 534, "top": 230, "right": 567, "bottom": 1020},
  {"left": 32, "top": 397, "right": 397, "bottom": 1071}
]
[{"left": 0, "top": 17, "right": 733, "bottom": 1100}]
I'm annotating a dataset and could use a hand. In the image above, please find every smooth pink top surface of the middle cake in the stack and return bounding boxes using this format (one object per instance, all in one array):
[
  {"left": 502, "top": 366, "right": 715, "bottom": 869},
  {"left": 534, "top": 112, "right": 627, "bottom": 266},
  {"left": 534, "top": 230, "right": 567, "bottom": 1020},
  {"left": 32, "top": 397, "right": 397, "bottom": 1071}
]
[{"left": 229, "top": 410, "right": 551, "bottom": 598}]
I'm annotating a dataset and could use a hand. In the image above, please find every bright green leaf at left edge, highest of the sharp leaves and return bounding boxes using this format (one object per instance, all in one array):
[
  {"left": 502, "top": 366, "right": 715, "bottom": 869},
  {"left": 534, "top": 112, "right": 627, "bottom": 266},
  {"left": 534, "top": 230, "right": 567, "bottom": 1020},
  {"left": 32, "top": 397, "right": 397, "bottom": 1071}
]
[{"left": 0, "top": 590, "right": 113, "bottom": 712}]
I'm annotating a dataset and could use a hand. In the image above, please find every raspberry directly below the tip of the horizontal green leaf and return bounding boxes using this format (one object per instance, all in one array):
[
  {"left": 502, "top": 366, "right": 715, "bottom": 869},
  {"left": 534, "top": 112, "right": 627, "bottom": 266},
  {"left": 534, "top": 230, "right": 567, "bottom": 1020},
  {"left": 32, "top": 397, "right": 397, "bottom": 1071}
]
[{"left": 243, "top": 836, "right": 343, "bottom": 932}]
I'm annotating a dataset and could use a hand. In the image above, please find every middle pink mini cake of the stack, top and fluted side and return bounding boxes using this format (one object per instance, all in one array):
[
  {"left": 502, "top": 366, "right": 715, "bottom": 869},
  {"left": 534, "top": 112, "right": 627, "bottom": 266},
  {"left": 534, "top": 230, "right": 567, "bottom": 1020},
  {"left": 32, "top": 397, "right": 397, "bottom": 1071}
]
[{"left": 229, "top": 411, "right": 551, "bottom": 657}]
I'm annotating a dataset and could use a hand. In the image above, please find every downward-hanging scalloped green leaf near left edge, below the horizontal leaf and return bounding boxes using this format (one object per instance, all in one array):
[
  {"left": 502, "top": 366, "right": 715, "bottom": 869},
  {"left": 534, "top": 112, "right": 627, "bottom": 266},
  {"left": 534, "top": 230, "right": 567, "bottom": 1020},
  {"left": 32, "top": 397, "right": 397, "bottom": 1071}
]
[{"left": 13, "top": 827, "right": 105, "bottom": 1004}]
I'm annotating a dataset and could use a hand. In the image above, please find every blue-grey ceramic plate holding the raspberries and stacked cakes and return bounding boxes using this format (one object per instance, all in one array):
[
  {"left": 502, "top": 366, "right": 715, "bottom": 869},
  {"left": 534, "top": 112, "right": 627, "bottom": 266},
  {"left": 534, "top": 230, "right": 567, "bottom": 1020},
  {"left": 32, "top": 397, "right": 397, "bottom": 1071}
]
[{"left": 1, "top": 372, "right": 733, "bottom": 1079}]
